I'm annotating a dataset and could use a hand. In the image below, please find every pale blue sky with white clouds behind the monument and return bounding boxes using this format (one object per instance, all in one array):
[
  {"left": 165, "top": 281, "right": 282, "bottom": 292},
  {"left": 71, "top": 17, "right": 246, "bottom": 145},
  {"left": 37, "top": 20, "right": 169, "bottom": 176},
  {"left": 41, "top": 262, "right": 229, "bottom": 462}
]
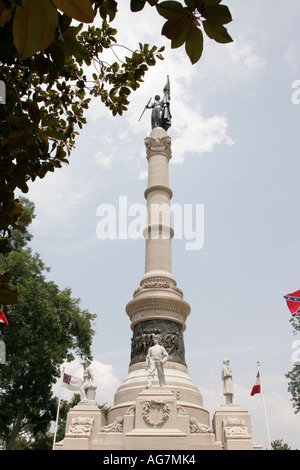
[{"left": 19, "top": 0, "right": 300, "bottom": 449}]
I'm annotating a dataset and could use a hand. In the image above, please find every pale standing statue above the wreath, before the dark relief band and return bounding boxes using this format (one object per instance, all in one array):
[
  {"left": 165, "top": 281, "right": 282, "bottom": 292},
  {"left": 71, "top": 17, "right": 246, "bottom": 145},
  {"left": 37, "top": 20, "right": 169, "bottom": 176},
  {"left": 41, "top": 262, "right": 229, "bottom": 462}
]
[{"left": 145, "top": 335, "right": 169, "bottom": 388}]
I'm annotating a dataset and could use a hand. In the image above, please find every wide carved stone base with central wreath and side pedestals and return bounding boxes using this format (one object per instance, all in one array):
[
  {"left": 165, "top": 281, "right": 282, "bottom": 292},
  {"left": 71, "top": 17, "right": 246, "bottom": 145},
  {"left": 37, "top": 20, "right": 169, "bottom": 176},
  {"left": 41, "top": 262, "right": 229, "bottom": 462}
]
[{"left": 55, "top": 392, "right": 262, "bottom": 450}]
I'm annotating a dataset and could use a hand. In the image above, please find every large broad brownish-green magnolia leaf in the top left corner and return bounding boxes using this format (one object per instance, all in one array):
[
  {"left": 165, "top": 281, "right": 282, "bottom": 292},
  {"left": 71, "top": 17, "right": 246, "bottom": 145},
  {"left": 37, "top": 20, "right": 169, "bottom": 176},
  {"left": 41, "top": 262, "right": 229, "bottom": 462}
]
[{"left": 12, "top": 0, "right": 58, "bottom": 60}]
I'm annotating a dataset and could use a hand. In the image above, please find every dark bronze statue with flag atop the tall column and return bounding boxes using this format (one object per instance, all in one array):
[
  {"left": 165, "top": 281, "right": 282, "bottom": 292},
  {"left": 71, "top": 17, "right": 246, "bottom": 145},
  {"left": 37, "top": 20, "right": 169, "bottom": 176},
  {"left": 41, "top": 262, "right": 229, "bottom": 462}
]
[{"left": 139, "top": 76, "right": 172, "bottom": 131}]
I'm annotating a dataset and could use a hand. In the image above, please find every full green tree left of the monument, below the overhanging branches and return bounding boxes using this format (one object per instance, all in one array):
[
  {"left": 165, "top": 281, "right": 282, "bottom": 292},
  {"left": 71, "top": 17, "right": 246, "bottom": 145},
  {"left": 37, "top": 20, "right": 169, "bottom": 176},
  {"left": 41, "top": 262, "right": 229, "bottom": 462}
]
[{"left": 0, "top": 200, "right": 95, "bottom": 449}]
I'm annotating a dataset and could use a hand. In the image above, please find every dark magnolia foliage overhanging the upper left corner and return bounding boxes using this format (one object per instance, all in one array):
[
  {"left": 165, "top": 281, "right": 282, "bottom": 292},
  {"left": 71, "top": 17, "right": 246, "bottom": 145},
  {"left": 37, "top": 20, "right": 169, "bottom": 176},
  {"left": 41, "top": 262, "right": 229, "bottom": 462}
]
[{"left": 0, "top": 0, "right": 232, "bottom": 305}]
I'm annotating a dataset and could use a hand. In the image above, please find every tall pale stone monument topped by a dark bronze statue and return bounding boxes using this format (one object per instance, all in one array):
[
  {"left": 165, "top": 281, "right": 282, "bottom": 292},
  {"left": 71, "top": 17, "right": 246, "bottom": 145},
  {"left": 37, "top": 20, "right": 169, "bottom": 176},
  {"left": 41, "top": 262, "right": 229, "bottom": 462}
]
[{"left": 56, "top": 79, "right": 262, "bottom": 450}]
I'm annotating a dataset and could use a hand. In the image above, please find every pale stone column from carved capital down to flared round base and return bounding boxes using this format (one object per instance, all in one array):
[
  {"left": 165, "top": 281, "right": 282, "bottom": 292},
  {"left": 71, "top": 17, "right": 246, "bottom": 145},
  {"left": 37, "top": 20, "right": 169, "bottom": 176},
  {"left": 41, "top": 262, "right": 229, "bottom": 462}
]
[{"left": 109, "top": 127, "right": 209, "bottom": 425}]
